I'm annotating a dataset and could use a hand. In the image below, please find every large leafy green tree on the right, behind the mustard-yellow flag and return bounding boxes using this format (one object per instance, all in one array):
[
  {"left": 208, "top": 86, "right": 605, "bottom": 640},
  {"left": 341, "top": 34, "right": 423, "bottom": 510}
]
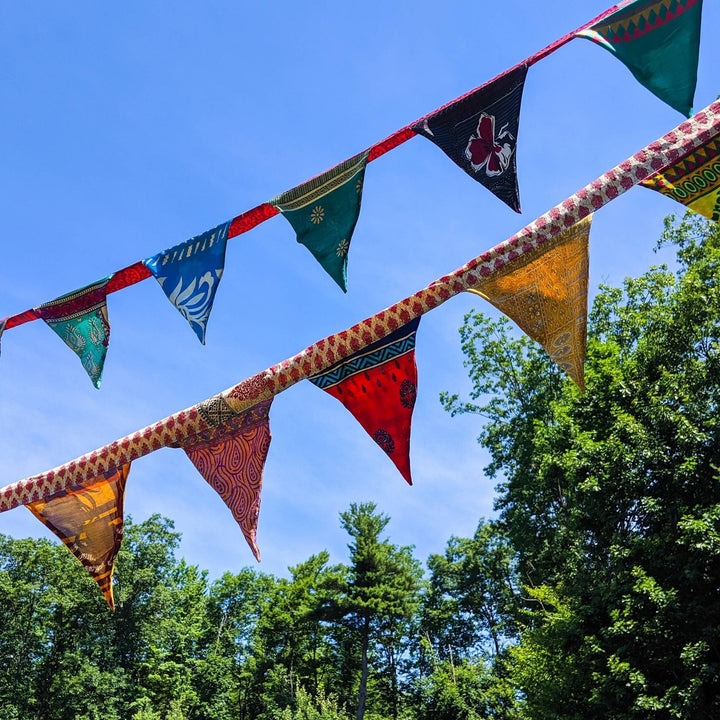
[{"left": 444, "top": 213, "right": 720, "bottom": 718}]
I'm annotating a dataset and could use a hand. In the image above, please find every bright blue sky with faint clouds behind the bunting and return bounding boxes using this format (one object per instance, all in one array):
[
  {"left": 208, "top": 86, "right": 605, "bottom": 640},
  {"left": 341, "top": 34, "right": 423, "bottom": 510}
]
[{"left": 0, "top": 0, "right": 720, "bottom": 576}]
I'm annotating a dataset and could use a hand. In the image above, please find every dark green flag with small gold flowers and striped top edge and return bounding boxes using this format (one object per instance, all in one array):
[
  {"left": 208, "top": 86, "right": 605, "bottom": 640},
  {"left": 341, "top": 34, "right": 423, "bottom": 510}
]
[{"left": 269, "top": 150, "right": 369, "bottom": 292}]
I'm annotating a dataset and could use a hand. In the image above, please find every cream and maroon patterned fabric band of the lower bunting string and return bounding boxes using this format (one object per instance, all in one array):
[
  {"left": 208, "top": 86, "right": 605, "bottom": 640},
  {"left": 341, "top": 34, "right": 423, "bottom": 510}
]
[{"left": 0, "top": 102, "right": 720, "bottom": 536}]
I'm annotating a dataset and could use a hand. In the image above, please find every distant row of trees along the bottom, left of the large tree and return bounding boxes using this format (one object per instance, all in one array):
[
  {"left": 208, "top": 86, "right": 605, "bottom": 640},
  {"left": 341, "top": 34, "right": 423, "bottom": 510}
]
[{"left": 0, "top": 503, "right": 512, "bottom": 720}]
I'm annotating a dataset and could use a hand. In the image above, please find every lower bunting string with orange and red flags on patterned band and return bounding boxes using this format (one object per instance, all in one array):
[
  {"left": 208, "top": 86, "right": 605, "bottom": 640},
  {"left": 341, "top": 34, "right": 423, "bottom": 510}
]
[{"left": 0, "top": 102, "right": 720, "bottom": 607}]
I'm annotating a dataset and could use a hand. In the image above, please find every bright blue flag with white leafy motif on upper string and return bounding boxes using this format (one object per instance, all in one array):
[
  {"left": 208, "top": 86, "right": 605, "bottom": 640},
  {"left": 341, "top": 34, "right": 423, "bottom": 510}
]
[{"left": 143, "top": 222, "right": 230, "bottom": 345}]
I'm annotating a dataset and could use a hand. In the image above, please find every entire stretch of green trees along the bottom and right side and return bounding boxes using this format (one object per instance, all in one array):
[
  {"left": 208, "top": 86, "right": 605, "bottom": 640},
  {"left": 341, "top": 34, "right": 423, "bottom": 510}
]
[{"left": 0, "top": 213, "right": 720, "bottom": 720}]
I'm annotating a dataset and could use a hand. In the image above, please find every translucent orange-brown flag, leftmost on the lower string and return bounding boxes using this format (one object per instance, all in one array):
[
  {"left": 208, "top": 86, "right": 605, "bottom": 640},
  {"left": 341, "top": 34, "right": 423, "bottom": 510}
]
[{"left": 26, "top": 463, "right": 130, "bottom": 610}]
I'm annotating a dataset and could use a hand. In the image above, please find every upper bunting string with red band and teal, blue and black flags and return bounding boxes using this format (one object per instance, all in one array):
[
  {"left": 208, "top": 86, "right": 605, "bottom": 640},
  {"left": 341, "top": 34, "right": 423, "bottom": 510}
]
[{"left": 0, "top": 0, "right": 708, "bottom": 387}]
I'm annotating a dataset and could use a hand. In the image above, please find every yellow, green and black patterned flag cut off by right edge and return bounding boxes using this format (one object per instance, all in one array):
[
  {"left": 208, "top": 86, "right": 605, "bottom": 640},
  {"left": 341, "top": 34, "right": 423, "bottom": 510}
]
[{"left": 640, "top": 137, "right": 720, "bottom": 222}]
